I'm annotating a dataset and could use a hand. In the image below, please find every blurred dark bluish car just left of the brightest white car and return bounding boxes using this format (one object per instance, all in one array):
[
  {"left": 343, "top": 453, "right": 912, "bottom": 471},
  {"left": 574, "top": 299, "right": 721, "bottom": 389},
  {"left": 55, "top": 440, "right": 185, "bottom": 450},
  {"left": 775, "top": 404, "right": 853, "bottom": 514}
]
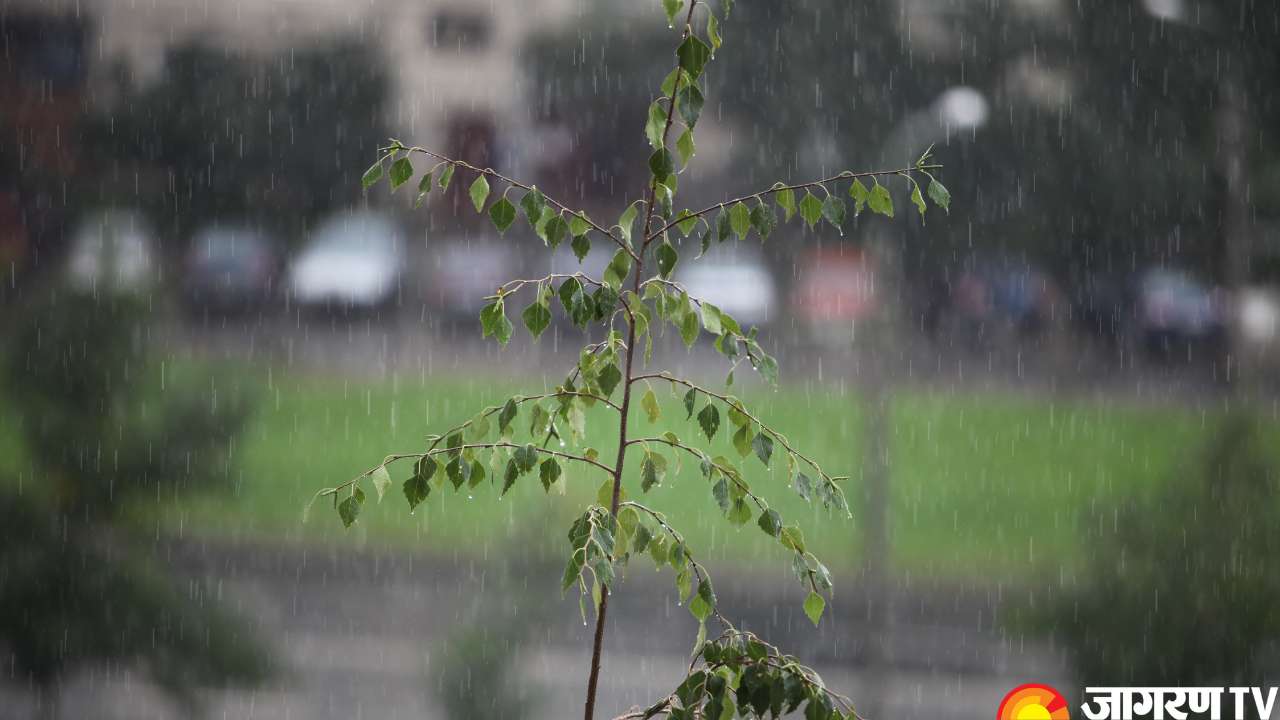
[{"left": 182, "top": 225, "right": 280, "bottom": 311}]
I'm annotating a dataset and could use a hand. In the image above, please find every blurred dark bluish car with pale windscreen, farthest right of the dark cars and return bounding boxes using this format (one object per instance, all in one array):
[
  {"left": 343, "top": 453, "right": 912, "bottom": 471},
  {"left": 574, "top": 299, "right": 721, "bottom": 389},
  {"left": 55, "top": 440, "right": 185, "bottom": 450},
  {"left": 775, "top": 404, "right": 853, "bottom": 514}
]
[{"left": 1135, "top": 268, "right": 1225, "bottom": 357}]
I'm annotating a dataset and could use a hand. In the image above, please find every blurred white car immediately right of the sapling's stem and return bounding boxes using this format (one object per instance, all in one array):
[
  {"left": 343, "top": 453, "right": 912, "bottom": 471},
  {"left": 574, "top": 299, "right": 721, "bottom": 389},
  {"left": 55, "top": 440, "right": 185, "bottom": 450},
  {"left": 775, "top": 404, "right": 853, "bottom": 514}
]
[{"left": 675, "top": 242, "right": 777, "bottom": 329}]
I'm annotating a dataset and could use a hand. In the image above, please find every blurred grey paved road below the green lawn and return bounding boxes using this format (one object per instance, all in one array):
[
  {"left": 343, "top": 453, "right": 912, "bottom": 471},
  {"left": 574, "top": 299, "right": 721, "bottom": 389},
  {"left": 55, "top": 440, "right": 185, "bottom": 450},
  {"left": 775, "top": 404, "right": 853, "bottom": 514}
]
[{"left": 0, "top": 543, "right": 1065, "bottom": 720}]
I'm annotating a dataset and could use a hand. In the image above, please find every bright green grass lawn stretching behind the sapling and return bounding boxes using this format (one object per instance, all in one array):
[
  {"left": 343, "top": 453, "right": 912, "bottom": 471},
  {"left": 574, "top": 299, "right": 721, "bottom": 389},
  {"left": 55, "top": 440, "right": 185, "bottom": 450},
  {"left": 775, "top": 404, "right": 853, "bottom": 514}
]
[{"left": 143, "top": 363, "right": 1239, "bottom": 579}]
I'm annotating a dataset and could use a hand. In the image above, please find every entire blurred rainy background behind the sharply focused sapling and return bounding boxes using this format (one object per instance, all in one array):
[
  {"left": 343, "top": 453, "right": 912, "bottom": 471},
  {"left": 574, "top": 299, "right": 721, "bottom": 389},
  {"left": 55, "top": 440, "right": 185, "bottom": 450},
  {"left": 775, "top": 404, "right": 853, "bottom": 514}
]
[{"left": 0, "top": 0, "right": 1280, "bottom": 719}]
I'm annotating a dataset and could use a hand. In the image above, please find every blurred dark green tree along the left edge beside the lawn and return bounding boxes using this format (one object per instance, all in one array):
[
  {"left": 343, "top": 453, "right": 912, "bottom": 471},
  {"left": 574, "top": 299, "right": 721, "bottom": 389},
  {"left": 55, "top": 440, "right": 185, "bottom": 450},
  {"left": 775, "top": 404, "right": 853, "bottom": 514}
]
[{"left": 0, "top": 293, "right": 269, "bottom": 716}]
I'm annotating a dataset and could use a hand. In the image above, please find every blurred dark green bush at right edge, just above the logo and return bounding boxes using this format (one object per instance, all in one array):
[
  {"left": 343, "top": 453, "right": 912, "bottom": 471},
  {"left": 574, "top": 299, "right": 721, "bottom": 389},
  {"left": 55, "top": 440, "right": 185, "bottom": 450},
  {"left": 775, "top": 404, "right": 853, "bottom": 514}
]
[{"left": 1043, "top": 413, "right": 1280, "bottom": 685}]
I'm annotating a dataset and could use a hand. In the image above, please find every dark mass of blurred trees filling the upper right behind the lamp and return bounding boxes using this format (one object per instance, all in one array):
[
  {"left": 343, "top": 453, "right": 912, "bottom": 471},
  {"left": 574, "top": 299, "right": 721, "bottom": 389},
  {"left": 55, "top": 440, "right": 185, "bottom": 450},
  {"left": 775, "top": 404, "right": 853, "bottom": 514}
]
[{"left": 721, "top": 0, "right": 1280, "bottom": 285}]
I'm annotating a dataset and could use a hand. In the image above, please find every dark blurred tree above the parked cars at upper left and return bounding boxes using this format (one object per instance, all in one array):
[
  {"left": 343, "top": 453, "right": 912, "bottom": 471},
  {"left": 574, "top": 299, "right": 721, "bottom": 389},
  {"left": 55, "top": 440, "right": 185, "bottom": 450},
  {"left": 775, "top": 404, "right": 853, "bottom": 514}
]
[{"left": 86, "top": 40, "right": 388, "bottom": 251}]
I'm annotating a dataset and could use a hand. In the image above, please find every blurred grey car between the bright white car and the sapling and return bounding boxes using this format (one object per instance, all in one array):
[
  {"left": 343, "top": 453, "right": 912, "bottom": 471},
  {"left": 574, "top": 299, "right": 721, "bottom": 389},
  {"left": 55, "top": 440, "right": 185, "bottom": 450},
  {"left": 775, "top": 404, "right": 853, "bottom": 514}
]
[{"left": 425, "top": 236, "right": 514, "bottom": 320}]
